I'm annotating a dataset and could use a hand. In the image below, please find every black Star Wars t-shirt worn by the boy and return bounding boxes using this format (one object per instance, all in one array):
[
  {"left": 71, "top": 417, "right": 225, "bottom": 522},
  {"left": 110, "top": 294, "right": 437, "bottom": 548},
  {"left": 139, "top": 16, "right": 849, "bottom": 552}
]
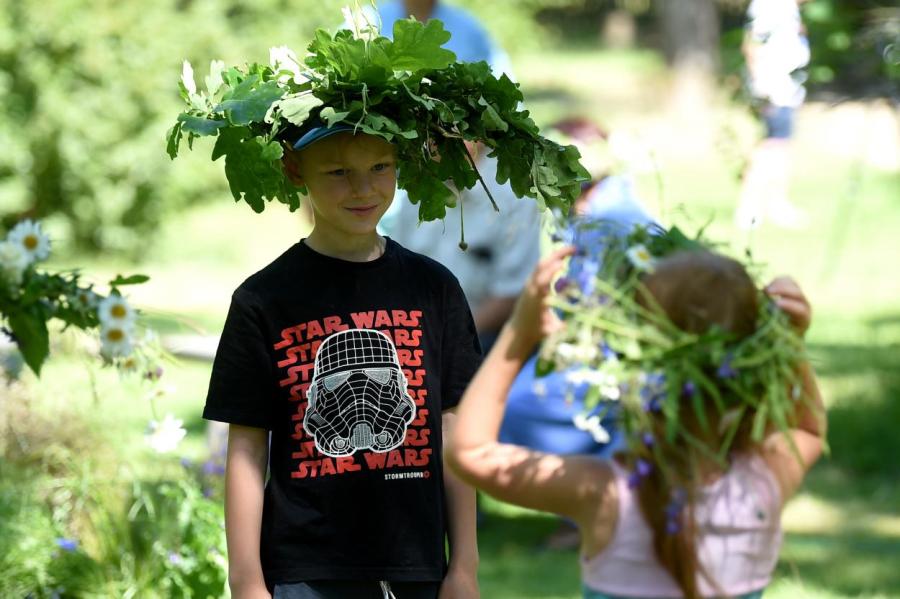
[{"left": 203, "top": 239, "right": 481, "bottom": 586}]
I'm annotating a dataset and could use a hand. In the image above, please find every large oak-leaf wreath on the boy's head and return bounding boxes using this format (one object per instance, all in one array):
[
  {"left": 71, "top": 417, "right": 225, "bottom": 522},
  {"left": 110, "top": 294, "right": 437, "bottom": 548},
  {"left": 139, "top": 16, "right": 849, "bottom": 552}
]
[{"left": 167, "top": 10, "right": 589, "bottom": 221}]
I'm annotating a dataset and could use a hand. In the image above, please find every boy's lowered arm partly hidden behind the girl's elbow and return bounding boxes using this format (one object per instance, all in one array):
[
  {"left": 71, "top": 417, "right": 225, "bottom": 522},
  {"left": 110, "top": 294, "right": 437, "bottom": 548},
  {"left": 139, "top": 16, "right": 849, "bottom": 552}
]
[{"left": 439, "top": 410, "right": 479, "bottom": 599}]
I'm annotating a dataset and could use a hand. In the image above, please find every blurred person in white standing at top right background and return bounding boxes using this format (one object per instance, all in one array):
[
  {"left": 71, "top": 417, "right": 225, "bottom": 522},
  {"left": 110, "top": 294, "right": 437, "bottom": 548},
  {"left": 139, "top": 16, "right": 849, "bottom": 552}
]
[{"left": 735, "top": 0, "right": 810, "bottom": 229}]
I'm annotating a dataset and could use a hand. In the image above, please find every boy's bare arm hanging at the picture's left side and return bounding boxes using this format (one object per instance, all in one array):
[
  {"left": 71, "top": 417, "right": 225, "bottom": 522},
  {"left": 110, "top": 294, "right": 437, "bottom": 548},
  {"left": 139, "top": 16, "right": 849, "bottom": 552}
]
[{"left": 225, "top": 424, "right": 271, "bottom": 599}]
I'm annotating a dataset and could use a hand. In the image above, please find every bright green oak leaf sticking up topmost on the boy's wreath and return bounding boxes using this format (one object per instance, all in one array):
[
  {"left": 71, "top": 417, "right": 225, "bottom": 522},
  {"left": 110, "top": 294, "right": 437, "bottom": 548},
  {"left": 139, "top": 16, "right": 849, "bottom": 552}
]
[{"left": 386, "top": 17, "right": 456, "bottom": 72}]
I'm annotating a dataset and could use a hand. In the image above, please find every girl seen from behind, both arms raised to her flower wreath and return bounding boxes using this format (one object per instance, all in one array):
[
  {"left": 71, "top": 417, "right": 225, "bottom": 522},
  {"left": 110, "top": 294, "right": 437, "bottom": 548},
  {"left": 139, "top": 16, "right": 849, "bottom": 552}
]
[{"left": 446, "top": 248, "right": 825, "bottom": 599}]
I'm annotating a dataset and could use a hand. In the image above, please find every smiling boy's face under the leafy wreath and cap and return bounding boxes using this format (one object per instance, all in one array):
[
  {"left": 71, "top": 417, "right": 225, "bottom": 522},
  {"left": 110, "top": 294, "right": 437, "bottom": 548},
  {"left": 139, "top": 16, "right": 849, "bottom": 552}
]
[{"left": 285, "top": 132, "right": 397, "bottom": 236}]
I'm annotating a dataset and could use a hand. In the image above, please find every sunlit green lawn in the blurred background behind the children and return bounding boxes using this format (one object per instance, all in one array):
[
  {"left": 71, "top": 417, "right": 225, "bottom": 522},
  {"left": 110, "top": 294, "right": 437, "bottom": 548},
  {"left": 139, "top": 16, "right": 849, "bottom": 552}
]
[{"left": 8, "top": 51, "right": 900, "bottom": 599}]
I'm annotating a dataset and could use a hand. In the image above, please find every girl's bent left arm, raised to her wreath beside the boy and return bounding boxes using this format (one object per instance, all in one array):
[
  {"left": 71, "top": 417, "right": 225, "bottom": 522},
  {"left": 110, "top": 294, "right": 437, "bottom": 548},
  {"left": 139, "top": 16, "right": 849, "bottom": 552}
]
[{"left": 445, "top": 248, "right": 614, "bottom": 530}]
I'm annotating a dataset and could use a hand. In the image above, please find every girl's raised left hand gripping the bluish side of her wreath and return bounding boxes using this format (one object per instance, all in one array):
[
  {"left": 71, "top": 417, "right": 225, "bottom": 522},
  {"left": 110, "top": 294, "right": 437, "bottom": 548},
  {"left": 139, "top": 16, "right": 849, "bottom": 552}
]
[{"left": 509, "top": 247, "right": 575, "bottom": 347}]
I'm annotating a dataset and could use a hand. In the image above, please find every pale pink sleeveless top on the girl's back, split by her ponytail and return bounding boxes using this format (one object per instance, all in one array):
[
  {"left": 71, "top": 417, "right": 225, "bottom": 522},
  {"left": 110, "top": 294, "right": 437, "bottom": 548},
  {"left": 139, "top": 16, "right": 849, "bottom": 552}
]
[{"left": 581, "top": 455, "right": 781, "bottom": 597}]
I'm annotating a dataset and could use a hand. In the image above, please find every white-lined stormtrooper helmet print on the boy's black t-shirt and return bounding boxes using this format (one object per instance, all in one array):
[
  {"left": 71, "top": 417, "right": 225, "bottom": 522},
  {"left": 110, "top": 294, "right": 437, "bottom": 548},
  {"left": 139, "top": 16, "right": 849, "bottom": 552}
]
[{"left": 303, "top": 329, "right": 416, "bottom": 457}]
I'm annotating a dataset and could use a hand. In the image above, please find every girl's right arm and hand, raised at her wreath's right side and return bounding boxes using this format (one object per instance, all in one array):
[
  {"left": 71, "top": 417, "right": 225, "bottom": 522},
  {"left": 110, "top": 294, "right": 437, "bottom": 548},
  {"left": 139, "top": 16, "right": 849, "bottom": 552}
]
[{"left": 763, "top": 277, "right": 828, "bottom": 500}]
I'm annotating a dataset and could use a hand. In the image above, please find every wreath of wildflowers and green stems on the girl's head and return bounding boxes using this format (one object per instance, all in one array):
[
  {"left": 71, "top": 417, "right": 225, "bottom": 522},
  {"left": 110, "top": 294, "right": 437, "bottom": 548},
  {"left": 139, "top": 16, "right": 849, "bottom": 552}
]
[{"left": 538, "top": 221, "right": 805, "bottom": 520}]
